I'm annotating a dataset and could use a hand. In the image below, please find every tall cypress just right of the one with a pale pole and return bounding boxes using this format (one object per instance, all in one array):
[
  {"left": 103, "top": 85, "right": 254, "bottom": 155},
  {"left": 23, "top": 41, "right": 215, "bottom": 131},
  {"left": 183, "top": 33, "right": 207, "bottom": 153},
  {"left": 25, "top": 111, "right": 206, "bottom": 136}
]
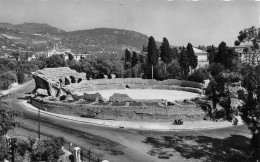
[{"left": 160, "top": 37, "right": 172, "bottom": 74}]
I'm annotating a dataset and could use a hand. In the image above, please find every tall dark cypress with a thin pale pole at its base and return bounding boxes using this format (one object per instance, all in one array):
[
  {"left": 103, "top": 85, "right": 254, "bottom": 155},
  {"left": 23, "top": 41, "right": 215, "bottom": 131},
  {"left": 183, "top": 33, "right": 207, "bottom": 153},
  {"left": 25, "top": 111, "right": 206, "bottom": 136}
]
[{"left": 147, "top": 36, "right": 158, "bottom": 79}]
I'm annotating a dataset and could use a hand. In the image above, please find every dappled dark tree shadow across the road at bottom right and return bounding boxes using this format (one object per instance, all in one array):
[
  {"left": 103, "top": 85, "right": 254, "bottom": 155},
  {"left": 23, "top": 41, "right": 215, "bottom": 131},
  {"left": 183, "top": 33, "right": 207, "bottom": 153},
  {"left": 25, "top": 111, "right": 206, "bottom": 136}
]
[{"left": 143, "top": 135, "right": 250, "bottom": 162}]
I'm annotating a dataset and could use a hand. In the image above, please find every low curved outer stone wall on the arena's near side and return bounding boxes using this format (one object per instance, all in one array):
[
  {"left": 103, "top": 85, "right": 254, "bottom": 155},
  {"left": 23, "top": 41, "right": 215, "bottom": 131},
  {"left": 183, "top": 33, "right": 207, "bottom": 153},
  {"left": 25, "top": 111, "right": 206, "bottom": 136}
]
[{"left": 31, "top": 99, "right": 206, "bottom": 121}]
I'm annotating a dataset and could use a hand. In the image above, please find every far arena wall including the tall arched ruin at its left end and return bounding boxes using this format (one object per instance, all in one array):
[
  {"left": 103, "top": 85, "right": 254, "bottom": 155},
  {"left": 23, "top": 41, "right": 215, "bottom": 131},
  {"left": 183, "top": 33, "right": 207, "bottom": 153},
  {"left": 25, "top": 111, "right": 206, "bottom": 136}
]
[{"left": 32, "top": 67, "right": 203, "bottom": 100}]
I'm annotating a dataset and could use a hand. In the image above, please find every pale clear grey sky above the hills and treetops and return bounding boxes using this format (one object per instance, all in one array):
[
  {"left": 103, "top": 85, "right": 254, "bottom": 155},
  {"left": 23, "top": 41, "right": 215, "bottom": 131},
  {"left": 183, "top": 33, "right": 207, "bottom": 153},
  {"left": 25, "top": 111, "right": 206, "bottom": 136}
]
[{"left": 0, "top": 0, "right": 260, "bottom": 46}]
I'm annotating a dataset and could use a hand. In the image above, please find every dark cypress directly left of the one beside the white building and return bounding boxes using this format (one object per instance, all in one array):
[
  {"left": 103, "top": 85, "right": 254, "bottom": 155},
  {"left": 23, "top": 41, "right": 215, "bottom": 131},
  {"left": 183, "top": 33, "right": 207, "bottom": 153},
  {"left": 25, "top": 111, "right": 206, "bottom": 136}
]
[{"left": 179, "top": 47, "right": 189, "bottom": 78}]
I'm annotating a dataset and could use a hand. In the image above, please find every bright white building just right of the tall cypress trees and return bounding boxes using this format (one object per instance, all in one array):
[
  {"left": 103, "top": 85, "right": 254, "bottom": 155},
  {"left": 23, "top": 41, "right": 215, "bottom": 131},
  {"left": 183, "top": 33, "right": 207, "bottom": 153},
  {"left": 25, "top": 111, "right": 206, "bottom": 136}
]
[{"left": 193, "top": 47, "right": 209, "bottom": 69}]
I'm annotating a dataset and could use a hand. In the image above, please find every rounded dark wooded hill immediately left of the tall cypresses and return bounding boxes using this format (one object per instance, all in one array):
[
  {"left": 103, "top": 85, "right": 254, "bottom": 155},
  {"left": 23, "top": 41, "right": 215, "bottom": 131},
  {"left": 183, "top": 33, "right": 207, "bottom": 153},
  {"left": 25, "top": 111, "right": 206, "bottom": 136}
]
[{"left": 61, "top": 28, "right": 154, "bottom": 52}]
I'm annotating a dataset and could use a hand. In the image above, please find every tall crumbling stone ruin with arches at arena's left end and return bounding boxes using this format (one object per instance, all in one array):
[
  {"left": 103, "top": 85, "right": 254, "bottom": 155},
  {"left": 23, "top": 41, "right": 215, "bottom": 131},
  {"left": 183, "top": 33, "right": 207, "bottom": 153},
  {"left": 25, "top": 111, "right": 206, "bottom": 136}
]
[{"left": 32, "top": 67, "right": 86, "bottom": 100}]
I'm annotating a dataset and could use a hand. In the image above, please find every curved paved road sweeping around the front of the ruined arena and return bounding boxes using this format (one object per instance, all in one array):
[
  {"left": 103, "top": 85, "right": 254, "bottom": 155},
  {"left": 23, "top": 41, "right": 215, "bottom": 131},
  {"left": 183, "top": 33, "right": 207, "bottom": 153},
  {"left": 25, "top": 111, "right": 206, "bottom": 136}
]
[{"left": 4, "top": 80, "right": 251, "bottom": 162}]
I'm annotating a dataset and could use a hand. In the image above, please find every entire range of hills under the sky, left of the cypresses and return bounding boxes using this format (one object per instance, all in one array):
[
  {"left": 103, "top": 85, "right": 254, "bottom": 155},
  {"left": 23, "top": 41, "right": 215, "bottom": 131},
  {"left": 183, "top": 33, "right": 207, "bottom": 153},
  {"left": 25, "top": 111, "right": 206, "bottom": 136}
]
[{"left": 0, "top": 23, "right": 160, "bottom": 54}]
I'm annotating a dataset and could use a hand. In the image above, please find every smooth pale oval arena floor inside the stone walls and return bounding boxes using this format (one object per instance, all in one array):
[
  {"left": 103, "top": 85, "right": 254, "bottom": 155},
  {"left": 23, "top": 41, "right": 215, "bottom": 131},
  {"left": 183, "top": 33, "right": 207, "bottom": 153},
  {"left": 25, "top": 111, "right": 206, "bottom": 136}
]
[{"left": 88, "top": 89, "right": 199, "bottom": 101}]
